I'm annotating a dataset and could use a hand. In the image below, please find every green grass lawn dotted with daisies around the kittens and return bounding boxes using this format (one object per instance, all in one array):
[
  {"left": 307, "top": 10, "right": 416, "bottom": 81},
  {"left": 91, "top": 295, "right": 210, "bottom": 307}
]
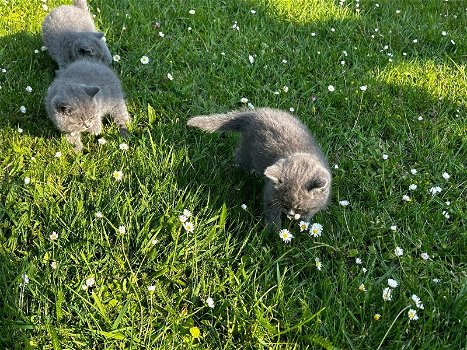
[{"left": 0, "top": 0, "right": 467, "bottom": 349}]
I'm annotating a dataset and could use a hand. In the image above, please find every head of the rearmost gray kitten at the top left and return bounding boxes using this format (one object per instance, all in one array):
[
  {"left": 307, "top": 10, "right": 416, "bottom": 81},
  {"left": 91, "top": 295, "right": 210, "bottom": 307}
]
[{"left": 71, "top": 32, "right": 112, "bottom": 65}]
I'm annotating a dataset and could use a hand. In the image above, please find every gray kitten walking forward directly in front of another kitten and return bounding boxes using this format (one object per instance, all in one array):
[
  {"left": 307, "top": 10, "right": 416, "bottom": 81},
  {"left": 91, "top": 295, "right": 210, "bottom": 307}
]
[{"left": 45, "top": 60, "right": 130, "bottom": 151}]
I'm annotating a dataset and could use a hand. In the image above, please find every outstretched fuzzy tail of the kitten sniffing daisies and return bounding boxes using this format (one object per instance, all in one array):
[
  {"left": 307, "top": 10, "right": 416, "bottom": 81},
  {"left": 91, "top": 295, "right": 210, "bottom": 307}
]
[{"left": 187, "top": 111, "right": 254, "bottom": 132}]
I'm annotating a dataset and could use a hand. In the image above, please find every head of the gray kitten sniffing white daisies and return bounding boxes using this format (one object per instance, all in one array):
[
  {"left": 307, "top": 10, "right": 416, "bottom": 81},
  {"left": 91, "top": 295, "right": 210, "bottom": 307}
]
[{"left": 264, "top": 154, "right": 331, "bottom": 219}]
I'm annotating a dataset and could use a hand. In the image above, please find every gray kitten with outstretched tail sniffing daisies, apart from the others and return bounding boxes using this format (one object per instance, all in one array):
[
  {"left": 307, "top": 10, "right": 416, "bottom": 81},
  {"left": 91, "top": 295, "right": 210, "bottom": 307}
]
[{"left": 188, "top": 108, "right": 331, "bottom": 228}]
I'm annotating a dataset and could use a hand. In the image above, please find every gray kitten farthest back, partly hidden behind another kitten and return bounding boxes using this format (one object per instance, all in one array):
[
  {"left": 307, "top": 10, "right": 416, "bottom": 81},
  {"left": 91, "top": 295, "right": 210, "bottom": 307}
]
[{"left": 42, "top": 0, "right": 112, "bottom": 68}]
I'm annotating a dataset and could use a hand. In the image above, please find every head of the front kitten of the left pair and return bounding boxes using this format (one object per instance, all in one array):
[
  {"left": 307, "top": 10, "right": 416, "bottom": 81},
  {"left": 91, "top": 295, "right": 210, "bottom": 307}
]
[{"left": 50, "top": 84, "right": 100, "bottom": 133}]
